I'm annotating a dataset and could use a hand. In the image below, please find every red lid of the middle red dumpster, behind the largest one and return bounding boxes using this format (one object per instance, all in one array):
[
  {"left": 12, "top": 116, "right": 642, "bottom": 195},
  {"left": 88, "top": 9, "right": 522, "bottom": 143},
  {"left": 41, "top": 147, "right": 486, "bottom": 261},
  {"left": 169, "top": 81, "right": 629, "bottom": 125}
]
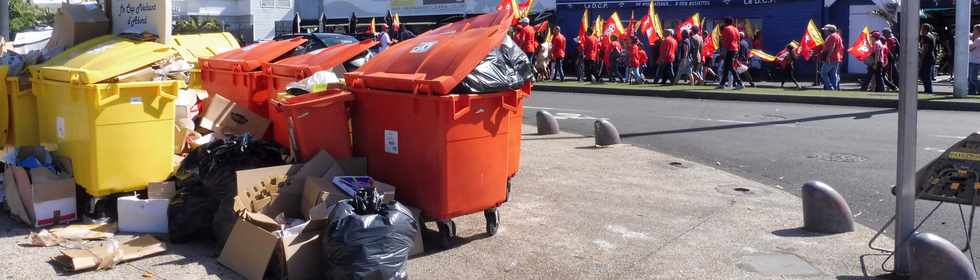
[{"left": 265, "top": 39, "right": 378, "bottom": 79}]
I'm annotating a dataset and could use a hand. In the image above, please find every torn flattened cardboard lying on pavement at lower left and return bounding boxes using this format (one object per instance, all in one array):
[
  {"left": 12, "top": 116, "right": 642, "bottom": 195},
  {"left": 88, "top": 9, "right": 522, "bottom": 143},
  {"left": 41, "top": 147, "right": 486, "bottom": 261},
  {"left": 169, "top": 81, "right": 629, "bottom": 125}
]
[{"left": 53, "top": 235, "right": 167, "bottom": 271}]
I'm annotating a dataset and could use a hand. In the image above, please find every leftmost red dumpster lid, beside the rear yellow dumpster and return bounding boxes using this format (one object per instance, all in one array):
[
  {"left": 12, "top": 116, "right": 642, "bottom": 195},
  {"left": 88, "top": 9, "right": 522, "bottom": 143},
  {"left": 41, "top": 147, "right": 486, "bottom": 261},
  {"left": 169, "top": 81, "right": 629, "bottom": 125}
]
[{"left": 198, "top": 37, "right": 306, "bottom": 72}]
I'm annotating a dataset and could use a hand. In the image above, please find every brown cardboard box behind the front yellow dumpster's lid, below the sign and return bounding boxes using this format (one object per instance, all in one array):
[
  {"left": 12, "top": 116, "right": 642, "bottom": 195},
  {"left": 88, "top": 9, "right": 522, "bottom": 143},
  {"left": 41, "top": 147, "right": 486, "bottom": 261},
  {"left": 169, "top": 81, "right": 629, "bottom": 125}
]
[{"left": 44, "top": 3, "right": 110, "bottom": 55}]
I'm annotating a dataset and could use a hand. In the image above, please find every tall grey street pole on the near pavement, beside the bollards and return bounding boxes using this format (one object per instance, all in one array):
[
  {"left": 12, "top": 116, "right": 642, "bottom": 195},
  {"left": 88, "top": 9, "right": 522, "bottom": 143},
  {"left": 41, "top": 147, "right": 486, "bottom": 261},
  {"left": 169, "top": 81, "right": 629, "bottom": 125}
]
[{"left": 895, "top": 0, "right": 919, "bottom": 275}]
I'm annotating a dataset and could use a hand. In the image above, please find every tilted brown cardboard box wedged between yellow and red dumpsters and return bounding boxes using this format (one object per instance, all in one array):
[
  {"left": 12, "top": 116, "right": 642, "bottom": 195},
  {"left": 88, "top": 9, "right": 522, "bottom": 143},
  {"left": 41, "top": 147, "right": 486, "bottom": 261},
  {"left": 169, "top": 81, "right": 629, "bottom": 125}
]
[{"left": 201, "top": 95, "right": 269, "bottom": 138}]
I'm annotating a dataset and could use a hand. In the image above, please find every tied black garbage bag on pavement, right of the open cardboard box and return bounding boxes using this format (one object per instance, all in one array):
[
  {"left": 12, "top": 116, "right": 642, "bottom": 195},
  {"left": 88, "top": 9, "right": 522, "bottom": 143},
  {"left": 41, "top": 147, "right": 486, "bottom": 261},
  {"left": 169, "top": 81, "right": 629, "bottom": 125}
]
[{"left": 321, "top": 188, "right": 418, "bottom": 280}]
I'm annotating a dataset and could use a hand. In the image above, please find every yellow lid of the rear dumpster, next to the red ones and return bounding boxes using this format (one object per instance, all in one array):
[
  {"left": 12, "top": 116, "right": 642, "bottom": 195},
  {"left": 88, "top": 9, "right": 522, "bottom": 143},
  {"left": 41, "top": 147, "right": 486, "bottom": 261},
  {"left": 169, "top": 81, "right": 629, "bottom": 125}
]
[{"left": 170, "top": 32, "right": 241, "bottom": 63}]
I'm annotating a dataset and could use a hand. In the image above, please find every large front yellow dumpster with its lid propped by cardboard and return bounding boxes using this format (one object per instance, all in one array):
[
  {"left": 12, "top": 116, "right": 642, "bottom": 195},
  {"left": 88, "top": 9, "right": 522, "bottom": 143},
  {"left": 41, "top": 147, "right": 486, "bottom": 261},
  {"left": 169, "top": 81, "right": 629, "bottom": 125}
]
[{"left": 31, "top": 36, "right": 181, "bottom": 197}]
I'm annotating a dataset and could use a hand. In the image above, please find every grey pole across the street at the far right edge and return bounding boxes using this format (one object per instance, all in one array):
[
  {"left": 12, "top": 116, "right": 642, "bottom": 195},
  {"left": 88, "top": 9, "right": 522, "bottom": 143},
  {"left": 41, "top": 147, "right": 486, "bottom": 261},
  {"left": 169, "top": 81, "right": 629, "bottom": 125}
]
[{"left": 953, "top": 0, "right": 973, "bottom": 97}]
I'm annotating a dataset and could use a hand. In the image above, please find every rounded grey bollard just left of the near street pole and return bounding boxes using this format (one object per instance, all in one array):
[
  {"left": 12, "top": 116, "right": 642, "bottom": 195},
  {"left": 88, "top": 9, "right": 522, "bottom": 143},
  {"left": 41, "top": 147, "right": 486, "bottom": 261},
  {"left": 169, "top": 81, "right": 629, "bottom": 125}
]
[{"left": 801, "top": 181, "right": 854, "bottom": 233}]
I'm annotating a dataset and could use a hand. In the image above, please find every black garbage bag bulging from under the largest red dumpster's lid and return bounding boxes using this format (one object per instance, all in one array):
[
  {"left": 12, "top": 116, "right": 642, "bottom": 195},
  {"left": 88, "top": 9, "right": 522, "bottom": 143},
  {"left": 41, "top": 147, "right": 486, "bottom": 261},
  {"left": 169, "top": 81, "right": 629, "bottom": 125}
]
[{"left": 456, "top": 36, "right": 534, "bottom": 93}]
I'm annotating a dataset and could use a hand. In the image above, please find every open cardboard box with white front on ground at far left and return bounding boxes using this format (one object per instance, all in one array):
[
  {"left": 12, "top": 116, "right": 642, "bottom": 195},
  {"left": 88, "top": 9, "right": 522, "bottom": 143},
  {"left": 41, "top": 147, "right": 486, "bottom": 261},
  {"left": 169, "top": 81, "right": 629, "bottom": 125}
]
[{"left": 3, "top": 148, "right": 78, "bottom": 227}]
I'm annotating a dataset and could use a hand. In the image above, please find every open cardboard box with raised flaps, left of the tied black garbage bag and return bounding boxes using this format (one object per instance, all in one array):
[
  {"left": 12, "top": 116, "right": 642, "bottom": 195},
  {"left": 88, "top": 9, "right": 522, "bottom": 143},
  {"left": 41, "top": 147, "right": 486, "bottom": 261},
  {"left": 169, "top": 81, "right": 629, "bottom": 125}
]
[{"left": 218, "top": 152, "right": 337, "bottom": 279}]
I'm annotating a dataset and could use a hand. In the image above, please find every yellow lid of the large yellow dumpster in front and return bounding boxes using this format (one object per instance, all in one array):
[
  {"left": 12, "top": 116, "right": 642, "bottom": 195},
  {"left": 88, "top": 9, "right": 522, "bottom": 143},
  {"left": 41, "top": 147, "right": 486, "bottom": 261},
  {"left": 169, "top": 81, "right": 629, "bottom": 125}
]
[{"left": 39, "top": 35, "right": 177, "bottom": 84}]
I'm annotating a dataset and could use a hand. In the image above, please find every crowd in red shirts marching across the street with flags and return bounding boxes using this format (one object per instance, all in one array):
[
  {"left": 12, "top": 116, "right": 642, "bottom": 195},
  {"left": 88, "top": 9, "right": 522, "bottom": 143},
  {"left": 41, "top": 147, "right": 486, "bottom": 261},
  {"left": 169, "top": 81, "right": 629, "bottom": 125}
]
[{"left": 513, "top": 18, "right": 980, "bottom": 94}]
